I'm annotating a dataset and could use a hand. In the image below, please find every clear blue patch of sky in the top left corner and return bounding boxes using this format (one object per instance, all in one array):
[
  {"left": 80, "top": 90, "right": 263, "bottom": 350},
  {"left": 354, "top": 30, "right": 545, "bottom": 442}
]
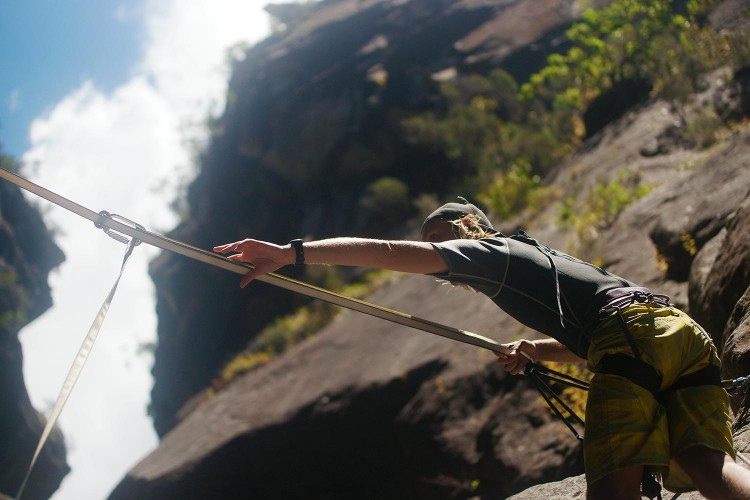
[{"left": 0, "top": 0, "right": 143, "bottom": 156}]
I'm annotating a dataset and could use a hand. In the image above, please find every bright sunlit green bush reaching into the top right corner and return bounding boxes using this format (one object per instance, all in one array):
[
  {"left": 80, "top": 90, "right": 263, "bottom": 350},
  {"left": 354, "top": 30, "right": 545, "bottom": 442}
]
[{"left": 520, "top": 0, "right": 750, "bottom": 132}]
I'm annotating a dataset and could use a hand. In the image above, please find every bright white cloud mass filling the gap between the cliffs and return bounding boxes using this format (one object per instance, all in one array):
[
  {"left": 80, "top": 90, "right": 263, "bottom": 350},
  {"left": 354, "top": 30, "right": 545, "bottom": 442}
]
[{"left": 21, "top": 0, "right": 268, "bottom": 500}]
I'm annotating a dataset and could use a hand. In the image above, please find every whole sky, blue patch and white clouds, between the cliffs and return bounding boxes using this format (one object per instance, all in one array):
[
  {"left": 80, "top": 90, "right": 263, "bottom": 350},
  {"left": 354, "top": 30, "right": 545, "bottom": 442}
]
[{"left": 0, "top": 0, "right": 269, "bottom": 500}]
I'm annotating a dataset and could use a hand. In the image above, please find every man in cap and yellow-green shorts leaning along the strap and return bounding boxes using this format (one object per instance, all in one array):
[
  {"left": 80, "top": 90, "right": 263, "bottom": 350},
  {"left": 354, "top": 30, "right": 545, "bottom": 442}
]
[{"left": 214, "top": 200, "right": 750, "bottom": 500}]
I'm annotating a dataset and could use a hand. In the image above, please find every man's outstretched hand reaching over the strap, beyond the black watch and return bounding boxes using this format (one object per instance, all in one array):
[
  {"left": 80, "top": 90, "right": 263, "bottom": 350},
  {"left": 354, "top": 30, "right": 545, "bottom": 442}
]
[{"left": 214, "top": 239, "right": 295, "bottom": 288}]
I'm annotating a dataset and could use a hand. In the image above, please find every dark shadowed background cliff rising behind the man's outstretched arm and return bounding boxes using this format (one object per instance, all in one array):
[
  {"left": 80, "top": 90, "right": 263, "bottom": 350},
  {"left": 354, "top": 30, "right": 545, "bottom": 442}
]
[{"left": 151, "top": 0, "right": 592, "bottom": 435}]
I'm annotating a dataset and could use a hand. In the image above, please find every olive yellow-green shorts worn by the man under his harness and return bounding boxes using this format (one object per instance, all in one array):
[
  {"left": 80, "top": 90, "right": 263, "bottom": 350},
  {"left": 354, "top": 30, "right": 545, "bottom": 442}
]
[{"left": 584, "top": 304, "right": 735, "bottom": 491}]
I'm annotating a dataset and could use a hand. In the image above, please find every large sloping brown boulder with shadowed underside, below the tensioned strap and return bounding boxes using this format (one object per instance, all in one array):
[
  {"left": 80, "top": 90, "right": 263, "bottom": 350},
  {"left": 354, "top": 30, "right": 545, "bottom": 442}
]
[{"left": 111, "top": 276, "right": 582, "bottom": 499}]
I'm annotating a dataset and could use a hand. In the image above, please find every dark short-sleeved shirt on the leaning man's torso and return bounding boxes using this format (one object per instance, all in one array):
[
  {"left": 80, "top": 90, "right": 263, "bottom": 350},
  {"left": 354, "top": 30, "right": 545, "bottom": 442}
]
[{"left": 433, "top": 233, "right": 637, "bottom": 358}]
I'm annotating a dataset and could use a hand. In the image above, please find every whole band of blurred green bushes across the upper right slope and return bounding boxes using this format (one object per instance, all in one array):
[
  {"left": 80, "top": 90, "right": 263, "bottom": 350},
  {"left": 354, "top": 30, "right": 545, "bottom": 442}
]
[{"left": 402, "top": 0, "right": 750, "bottom": 228}]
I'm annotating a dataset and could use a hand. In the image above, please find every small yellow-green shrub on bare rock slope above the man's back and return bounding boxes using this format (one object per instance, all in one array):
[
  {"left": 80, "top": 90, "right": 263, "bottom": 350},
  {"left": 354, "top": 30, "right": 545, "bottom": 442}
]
[{"left": 558, "top": 171, "right": 652, "bottom": 250}]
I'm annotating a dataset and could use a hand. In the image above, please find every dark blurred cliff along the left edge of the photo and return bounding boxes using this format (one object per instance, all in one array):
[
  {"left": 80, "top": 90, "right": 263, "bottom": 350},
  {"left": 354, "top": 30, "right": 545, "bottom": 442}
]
[{"left": 0, "top": 180, "right": 70, "bottom": 499}]
